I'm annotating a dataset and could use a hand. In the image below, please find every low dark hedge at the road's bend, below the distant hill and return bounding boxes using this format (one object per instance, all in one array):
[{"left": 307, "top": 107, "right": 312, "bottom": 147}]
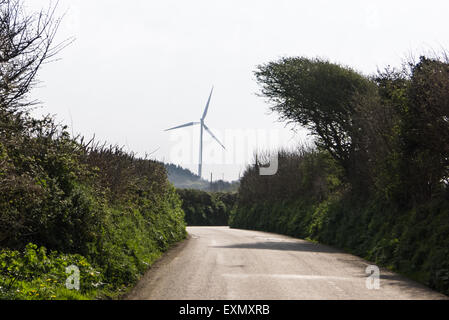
[{"left": 177, "top": 189, "right": 236, "bottom": 226}]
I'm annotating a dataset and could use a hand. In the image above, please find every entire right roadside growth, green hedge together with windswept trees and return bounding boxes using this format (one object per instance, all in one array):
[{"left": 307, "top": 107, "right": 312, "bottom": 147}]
[{"left": 230, "top": 53, "right": 449, "bottom": 294}]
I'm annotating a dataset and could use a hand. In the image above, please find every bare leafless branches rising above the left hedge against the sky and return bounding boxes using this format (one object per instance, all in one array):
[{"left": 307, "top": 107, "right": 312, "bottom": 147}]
[{"left": 0, "top": 0, "right": 70, "bottom": 111}]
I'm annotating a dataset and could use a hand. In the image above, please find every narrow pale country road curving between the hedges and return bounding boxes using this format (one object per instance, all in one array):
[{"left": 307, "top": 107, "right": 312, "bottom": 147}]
[{"left": 127, "top": 227, "right": 447, "bottom": 300}]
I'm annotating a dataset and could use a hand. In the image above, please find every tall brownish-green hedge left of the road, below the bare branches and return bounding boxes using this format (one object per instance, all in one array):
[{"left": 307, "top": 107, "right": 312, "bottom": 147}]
[{"left": 0, "top": 110, "right": 185, "bottom": 299}]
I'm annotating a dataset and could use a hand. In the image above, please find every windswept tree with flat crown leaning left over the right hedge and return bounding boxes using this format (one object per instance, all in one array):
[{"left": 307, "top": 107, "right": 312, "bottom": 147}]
[{"left": 255, "top": 58, "right": 374, "bottom": 180}]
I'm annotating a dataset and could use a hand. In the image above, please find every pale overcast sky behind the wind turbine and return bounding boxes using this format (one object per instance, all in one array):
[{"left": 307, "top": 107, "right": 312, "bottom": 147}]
[{"left": 26, "top": 0, "right": 449, "bottom": 180}]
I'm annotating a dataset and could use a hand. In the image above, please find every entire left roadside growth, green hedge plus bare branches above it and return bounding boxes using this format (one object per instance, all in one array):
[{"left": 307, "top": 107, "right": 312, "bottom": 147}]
[{"left": 0, "top": 0, "right": 186, "bottom": 299}]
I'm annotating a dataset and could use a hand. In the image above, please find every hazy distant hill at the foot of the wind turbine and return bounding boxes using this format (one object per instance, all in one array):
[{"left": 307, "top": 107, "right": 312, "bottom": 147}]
[{"left": 164, "top": 163, "right": 239, "bottom": 192}]
